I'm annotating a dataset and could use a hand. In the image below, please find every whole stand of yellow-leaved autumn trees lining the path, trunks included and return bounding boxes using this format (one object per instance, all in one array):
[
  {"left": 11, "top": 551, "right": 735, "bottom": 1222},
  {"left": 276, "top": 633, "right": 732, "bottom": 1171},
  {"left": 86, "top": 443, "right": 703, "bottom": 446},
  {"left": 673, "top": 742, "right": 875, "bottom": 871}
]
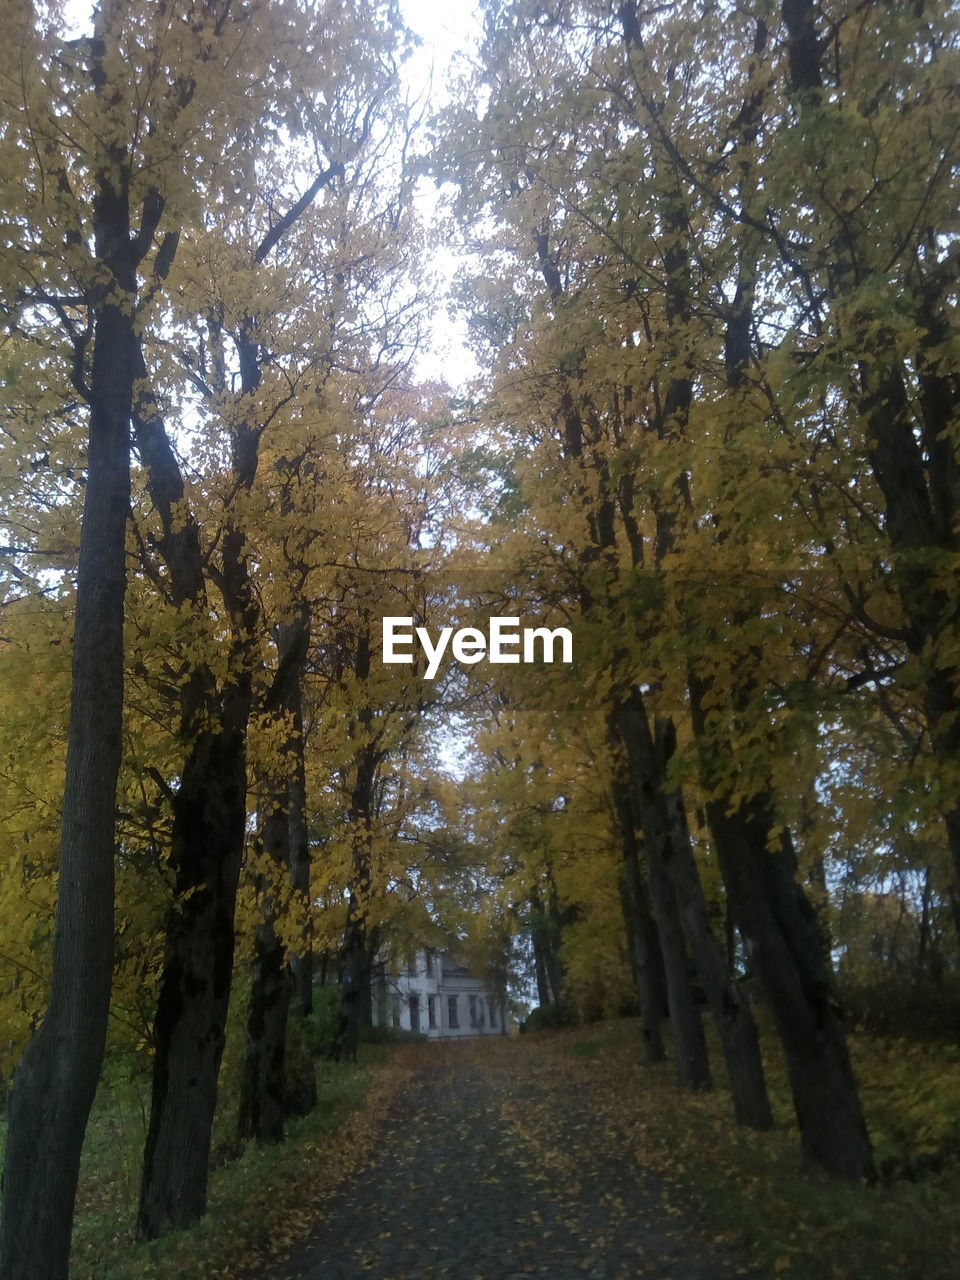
[{"left": 0, "top": 0, "right": 960, "bottom": 1280}]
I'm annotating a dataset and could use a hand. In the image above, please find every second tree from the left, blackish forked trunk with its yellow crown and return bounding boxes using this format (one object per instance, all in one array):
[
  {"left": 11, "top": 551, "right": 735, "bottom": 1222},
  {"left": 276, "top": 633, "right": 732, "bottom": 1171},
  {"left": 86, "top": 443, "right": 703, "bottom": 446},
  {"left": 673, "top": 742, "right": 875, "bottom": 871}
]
[{"left": 128, "top": 4, "right": 414, "bottom": 1239}]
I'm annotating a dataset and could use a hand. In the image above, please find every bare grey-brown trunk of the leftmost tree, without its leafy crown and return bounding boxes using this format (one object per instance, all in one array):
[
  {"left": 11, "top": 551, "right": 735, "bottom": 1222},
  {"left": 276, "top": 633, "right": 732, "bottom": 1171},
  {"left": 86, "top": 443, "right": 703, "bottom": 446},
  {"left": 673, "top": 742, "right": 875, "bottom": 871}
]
[{"left": 0, "top": 275, "right": 136, "bottom": 1280}]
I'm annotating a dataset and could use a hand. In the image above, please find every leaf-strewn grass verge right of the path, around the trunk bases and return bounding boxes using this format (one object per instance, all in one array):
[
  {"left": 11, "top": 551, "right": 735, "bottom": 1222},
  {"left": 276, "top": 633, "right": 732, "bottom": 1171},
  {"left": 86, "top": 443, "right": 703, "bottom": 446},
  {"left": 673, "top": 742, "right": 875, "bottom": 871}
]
[{"left": 547, "top": 1020, "right": 960, "bottom": 1280}]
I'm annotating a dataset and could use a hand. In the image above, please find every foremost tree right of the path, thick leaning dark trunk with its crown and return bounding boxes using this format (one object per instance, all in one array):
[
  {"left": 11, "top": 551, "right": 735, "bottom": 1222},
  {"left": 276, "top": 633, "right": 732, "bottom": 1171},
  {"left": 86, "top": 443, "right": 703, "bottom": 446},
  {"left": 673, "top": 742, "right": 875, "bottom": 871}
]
[{"left": 442, "top": 4, "right": 872, "bottom": 1179}]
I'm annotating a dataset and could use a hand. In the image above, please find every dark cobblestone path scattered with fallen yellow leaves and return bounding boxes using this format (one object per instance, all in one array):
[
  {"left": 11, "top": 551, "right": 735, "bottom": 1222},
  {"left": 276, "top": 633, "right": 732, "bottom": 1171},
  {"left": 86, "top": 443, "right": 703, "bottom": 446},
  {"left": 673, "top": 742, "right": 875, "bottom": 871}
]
[{"left": 262, "top": 1038, "right": 753, "bottom": 1280}]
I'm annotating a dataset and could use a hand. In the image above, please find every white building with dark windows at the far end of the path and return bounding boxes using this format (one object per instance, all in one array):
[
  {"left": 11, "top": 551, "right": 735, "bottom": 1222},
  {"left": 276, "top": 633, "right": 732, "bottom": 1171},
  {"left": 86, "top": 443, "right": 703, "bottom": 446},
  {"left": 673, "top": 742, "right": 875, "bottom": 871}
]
[{"left": 372, "top": 948, "right": 507, "bottom": 1039}]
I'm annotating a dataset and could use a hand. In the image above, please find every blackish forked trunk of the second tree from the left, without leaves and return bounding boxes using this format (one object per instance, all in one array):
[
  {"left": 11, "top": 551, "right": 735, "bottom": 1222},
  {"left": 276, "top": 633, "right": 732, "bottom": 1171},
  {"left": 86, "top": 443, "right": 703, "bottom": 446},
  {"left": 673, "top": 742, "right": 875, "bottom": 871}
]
[{"left": 134, "top": 312, "right": 261, "bottom": 1240}]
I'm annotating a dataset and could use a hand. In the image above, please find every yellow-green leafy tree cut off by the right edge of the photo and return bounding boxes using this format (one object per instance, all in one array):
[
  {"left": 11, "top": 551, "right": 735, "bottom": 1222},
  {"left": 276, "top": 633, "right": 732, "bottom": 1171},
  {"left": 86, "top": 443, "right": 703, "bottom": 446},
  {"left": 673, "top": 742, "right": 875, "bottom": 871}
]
[{"left": 780, "top": 0, "right": 960, "bottom": 934}]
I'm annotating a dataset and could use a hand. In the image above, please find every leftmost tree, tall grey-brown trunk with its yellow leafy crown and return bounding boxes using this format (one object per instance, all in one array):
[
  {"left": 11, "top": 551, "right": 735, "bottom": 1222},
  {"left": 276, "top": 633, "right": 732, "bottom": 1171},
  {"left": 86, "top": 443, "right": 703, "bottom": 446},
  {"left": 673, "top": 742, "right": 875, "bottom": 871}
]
[{"left": 0, "top": 0, "right": 227, "bottom": 1277}]
